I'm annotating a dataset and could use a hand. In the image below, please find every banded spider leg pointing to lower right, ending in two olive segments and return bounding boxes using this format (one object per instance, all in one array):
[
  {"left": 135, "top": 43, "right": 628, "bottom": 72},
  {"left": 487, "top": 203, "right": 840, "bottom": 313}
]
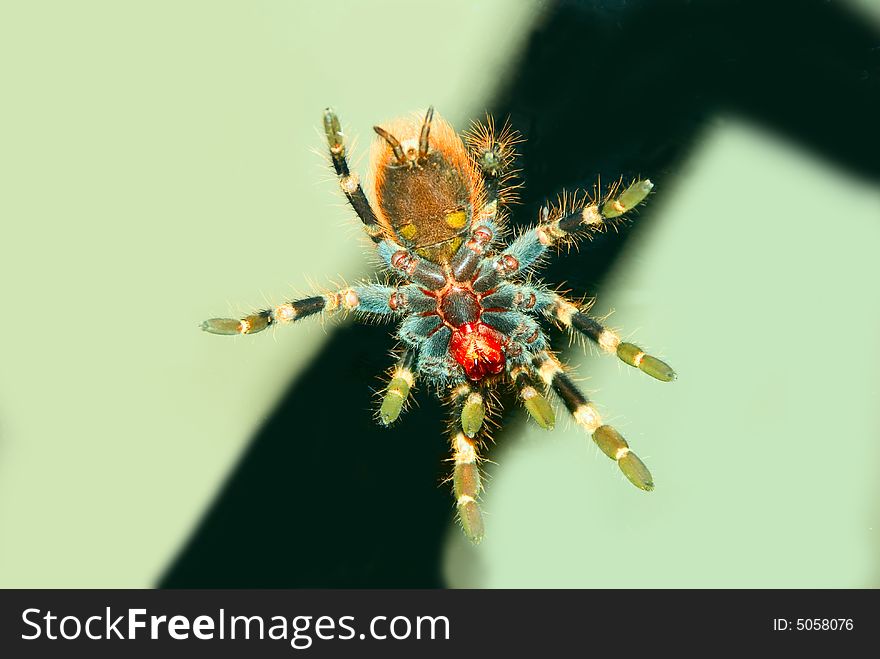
[{"left": 534, "top": 351, "right": 654, "bottom": 491}]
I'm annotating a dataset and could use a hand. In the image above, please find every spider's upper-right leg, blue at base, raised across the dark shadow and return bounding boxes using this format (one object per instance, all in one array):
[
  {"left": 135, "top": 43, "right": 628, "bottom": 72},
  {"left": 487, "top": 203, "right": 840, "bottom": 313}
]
[{"left": 474, "top": 180, "right": 654, "bottom": 293}]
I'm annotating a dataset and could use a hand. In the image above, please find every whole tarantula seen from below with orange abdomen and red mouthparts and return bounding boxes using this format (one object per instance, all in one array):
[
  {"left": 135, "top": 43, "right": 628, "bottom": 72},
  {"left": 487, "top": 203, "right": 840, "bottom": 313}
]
[{"left": 202, "top": 108, "right": 675, "bottom": 543}]
